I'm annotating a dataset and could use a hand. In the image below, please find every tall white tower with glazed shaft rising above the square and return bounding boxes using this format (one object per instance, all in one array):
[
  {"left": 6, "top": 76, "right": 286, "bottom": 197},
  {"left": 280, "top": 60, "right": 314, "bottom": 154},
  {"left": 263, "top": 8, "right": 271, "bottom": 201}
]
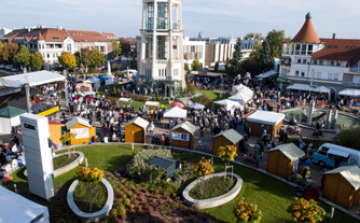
[{"left": 137, "top": 0, "right": 185, "bottom": 97}]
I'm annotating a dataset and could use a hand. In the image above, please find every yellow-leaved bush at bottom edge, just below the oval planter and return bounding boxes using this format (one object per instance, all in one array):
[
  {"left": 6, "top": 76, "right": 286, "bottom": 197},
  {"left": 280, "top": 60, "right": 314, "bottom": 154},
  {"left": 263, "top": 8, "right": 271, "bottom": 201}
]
[{"left": 234, "top": 198, "right": 262, "bottom": 223}]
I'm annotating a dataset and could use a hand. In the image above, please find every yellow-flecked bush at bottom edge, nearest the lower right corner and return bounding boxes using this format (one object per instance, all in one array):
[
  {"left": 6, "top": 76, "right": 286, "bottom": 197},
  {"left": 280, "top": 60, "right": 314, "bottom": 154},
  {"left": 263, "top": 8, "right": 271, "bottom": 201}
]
[{"left": 287, "top": 198, "right": 326, "bottom": 223}]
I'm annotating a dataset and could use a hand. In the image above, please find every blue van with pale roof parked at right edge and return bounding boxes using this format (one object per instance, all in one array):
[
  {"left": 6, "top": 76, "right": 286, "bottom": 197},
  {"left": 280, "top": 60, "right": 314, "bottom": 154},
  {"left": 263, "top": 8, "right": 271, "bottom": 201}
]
[{"left": 313, "top": 143, "right": 360, "bottom": 168}]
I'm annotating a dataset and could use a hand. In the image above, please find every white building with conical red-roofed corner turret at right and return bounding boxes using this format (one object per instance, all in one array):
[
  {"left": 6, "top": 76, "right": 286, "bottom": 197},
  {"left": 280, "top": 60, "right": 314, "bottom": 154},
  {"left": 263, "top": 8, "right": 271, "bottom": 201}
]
[{"left": 280, "top": 13, "right": 360, "bottom": 97}]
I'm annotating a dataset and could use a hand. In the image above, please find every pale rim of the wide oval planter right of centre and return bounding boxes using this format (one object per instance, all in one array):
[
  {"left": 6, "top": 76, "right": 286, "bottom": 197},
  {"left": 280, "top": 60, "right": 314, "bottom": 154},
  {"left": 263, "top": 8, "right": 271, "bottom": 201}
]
[{"left": 183, "top": 172, "right": 243, "bottom": 209}]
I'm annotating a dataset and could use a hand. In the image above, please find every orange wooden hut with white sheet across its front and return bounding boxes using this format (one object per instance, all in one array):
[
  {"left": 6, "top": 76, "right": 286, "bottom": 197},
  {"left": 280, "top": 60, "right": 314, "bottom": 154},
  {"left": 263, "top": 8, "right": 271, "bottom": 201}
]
[{"left": 66, "top": 117, "right": 96, "bottom": 145}]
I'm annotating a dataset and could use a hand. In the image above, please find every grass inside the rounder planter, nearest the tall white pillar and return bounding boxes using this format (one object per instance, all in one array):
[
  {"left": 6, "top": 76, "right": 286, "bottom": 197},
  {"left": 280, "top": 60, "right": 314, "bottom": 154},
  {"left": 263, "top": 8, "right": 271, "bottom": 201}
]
[{"left": 74, "top": 182, "right": 107, "bottom": 213}]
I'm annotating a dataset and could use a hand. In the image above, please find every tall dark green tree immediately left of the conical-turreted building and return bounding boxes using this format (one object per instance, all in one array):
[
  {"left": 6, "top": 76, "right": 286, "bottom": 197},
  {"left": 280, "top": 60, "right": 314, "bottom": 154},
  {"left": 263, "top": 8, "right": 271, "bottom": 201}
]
[{"left": 265, "top": 29, "right": 285, "bottom": 58}]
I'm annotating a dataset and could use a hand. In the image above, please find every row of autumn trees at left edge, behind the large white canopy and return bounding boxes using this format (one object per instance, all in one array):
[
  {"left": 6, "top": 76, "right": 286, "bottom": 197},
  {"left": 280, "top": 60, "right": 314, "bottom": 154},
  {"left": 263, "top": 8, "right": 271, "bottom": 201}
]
[{"left": 0, "top": 42, "right": 45, "bottom": 70}]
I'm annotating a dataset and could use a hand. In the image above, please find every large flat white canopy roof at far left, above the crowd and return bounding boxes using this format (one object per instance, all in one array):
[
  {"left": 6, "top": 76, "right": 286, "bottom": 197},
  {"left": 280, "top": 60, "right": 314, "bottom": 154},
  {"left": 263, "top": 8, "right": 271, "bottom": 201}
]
[{"left": 0, "top": 70, "right": 65, "bottom": 87}]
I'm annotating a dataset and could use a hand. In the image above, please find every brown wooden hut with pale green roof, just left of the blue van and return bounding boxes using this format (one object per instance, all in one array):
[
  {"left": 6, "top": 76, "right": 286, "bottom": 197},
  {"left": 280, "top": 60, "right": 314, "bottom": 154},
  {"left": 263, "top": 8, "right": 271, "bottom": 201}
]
[{"left": 266, "top": 143, "right": 305, "bottom": 178}]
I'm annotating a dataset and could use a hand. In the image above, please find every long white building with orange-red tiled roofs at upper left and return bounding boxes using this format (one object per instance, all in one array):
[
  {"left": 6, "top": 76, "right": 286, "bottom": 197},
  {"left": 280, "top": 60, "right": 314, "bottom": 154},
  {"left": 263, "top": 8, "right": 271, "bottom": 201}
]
[{"left": 0, "top": 26, "right": 112, "bottom": 70}]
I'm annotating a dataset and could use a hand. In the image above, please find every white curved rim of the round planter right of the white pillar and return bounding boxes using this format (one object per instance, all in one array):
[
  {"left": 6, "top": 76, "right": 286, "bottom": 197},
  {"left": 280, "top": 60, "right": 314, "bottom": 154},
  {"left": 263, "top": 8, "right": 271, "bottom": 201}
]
[{"left": 67, "top": 178, "right": 114, "bottom": 222}]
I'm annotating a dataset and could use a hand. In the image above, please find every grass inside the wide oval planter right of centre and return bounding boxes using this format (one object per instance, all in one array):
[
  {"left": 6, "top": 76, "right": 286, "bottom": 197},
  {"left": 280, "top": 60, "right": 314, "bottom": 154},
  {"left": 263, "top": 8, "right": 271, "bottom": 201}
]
[{"left": 189, "top": 176, "right": 236, "bottom": 200}]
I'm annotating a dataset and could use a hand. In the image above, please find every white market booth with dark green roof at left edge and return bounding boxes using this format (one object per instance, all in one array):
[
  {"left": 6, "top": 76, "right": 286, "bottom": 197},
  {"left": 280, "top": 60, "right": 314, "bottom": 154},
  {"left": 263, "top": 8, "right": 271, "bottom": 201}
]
[{"left": 0, "top": 106, "right": 26, "bottom": 134}]
